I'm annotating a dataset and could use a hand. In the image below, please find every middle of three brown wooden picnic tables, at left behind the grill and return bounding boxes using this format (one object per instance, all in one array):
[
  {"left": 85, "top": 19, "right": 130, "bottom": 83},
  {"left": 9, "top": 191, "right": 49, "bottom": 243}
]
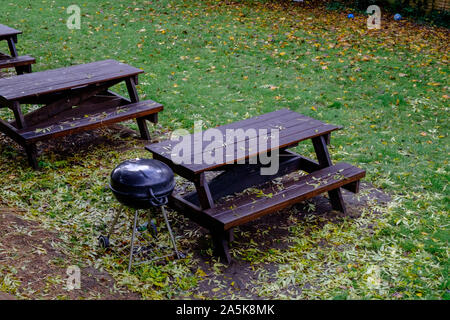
[{"left": 0, "top": 60, "right": 163, "bottom": 168}]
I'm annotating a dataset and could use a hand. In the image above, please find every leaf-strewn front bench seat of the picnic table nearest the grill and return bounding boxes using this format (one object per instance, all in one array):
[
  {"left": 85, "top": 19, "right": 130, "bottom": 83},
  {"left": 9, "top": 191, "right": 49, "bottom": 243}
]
[{"left": 203, "top": 162, "right": 365, "bottom": 230}]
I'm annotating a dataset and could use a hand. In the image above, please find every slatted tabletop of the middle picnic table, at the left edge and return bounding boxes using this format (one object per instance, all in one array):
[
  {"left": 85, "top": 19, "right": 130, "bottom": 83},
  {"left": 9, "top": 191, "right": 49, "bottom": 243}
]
[{"left": 0, "top": 60, "right": 144, "bottom": 101}]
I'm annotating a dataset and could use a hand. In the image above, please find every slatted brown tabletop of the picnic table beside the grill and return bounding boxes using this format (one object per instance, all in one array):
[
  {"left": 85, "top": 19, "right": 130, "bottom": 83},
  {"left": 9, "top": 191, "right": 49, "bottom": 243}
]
[{"left": 146, "top": 109, "right": 341, "bottom": 174}]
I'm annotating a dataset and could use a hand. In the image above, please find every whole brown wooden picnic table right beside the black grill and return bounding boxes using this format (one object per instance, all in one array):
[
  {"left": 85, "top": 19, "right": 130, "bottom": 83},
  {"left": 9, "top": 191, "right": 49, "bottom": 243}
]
[{"left": 146, "top": 109, "right": 365, "bottom": 262}]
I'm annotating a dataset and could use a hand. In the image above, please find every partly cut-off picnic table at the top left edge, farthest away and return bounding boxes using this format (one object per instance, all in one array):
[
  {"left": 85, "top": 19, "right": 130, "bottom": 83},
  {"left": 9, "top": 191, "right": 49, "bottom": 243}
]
[{"left": 0, "top": 24, "right": 36, "bottom": 74}]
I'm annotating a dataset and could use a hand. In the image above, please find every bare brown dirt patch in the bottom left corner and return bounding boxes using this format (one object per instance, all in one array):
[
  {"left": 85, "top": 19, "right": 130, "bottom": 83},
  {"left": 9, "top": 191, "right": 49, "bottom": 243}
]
[{"left": 0, "top": 208, "right": 139, "bottom": 300}]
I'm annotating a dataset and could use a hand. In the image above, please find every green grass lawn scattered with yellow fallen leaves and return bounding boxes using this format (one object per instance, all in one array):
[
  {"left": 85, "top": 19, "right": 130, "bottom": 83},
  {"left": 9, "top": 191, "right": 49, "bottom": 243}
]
[{"left": 0, "top": 0, "right": 450, "bottom": 299}]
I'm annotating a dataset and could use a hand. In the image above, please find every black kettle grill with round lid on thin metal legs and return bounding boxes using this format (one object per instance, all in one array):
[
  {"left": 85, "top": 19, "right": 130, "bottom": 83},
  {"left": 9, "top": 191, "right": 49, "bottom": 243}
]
[{"left": 99, "top": 159, "right": 182, "bottom": 272}]
